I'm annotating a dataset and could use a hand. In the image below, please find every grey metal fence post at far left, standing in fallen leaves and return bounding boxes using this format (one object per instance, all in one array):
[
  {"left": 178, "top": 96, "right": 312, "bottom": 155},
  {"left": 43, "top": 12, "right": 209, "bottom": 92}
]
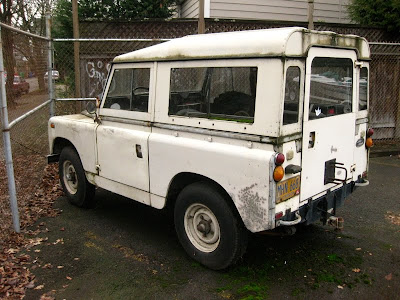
[{"left": 0, "top": 27, "right": 21, "bottom": 233}]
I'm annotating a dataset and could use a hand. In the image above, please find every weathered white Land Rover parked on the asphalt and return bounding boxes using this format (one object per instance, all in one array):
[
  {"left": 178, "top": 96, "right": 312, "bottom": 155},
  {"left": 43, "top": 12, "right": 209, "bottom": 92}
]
[{"left": 49, "top": 27, "right": 373, "bottom": 269}]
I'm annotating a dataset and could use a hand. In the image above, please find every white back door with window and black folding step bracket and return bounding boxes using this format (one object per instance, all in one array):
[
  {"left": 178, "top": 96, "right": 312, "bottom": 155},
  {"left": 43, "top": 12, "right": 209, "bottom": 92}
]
[{"left": 300, "top": 48, "right": 357, "bottom": 201}]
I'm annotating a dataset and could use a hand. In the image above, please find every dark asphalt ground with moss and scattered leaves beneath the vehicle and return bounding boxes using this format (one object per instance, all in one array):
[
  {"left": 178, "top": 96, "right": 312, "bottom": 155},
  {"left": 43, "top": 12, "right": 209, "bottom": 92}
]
[{"left": 0, "top": 156, "right": 390, "bottom": 300}]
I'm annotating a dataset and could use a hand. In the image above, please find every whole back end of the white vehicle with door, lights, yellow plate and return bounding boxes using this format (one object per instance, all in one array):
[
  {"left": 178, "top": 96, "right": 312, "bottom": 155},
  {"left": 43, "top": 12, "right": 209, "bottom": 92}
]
[{"left": 274, "top": 47, "right": 373, "bottom": 226}]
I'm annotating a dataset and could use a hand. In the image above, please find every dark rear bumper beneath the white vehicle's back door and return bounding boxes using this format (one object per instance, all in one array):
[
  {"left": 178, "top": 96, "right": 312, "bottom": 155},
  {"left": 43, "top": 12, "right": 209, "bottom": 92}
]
[{"left": 277, "top": 181, "right": 362, "bottom": 225}]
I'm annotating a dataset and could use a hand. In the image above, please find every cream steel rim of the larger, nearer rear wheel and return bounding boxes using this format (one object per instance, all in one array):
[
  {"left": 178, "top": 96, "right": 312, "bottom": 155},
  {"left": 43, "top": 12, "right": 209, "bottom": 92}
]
[{"left": 184, "top": 203, "right": 220, "bottom": 253}]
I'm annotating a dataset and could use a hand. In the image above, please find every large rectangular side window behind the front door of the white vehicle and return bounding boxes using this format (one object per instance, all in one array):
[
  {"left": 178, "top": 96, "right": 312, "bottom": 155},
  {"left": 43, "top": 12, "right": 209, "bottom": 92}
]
[{"left": 168, "top": 67, "right": 257, "bottom": 123}]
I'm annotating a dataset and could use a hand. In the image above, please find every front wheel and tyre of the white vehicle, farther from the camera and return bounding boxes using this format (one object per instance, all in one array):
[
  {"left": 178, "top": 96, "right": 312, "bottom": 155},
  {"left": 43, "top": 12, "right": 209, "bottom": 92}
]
[{"left": 58, "top": 147, "right": 95, "bottom": 208}]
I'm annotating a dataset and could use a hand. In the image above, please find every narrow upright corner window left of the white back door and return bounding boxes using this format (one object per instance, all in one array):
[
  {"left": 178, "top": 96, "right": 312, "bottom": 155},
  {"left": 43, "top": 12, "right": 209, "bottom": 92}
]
[{"left": 283, "top": 67, "right": 301, "bottom": 125}]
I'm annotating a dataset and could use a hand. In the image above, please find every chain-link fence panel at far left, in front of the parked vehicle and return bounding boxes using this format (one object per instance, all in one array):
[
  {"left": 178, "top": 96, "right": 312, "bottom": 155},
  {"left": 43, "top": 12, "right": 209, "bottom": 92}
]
[{"left": 0, "top": 24, "right": 50, "bottom": 234}]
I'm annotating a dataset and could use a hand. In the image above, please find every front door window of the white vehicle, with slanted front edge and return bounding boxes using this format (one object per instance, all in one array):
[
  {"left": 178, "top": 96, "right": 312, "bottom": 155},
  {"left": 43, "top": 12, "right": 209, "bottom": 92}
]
[{"left": 103, "top": 68, "right": 150, "bottom": 112}]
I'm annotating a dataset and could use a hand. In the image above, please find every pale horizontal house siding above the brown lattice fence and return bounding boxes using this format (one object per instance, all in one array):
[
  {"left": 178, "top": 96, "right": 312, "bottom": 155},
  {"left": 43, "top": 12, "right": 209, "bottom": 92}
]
[{"left": 209, "top": 0, "right": 349, "bottom": 23}]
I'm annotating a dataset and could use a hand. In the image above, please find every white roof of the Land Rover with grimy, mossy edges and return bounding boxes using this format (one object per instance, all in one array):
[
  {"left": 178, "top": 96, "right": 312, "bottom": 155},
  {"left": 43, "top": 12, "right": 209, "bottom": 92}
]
[{"left": 114, "top": 27, "right": 370, "bottom": 62}]
